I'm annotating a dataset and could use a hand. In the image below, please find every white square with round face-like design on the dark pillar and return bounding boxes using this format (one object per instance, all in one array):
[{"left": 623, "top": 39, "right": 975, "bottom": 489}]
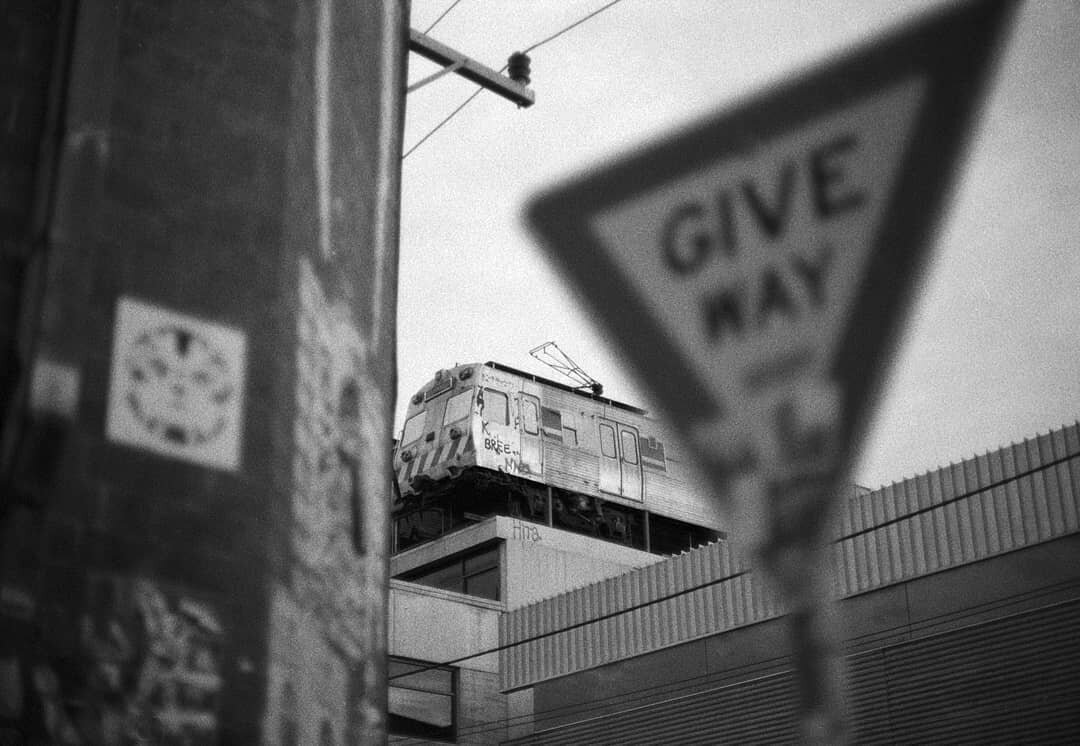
[{"left": 106, "top": 297, "right": 246, "bottom": 471}]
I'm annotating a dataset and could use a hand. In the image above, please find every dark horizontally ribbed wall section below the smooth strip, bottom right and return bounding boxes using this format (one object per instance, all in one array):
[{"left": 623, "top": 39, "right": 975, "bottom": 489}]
[{"left": 509, "top": 600, "right": 1080, "bottom": 746}]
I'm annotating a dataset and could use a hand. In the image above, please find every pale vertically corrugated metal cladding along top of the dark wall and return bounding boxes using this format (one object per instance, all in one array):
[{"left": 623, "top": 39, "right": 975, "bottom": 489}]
[{"left": 500, "top": 424, "right": 1080, "bottom": 689}]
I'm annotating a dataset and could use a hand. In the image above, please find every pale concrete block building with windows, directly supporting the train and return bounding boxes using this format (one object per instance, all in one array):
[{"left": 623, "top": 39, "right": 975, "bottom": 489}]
[{"left": 390, "top": 516, "right": 663, "bottom": 743}]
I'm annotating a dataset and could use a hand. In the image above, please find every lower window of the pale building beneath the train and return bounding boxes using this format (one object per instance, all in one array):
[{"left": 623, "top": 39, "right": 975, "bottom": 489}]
[{"left": 388, "top": 655, "right": 458, "bottom": 743}]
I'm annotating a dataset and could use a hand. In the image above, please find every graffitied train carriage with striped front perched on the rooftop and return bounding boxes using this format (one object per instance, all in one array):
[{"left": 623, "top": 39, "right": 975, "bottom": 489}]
[{"left": 393, "top": 362, "right": 723, "bottom": 553}]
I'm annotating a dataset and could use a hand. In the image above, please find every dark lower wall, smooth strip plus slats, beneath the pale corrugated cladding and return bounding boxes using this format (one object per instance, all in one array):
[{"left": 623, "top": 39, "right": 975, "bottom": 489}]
[{"left": 505, "top": 534, "right": 1080, "bottom": 744}]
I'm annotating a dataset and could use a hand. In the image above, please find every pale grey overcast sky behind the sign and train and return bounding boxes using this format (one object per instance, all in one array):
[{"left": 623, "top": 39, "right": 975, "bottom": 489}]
[{"left": 395, "top": 0, "right": 1080, "bottom": 488}]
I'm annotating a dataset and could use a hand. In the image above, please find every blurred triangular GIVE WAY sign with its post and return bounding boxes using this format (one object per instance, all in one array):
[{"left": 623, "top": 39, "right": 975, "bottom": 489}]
[{"left": 529, "top": 1, "right": 1010, "bottom": 743}]
